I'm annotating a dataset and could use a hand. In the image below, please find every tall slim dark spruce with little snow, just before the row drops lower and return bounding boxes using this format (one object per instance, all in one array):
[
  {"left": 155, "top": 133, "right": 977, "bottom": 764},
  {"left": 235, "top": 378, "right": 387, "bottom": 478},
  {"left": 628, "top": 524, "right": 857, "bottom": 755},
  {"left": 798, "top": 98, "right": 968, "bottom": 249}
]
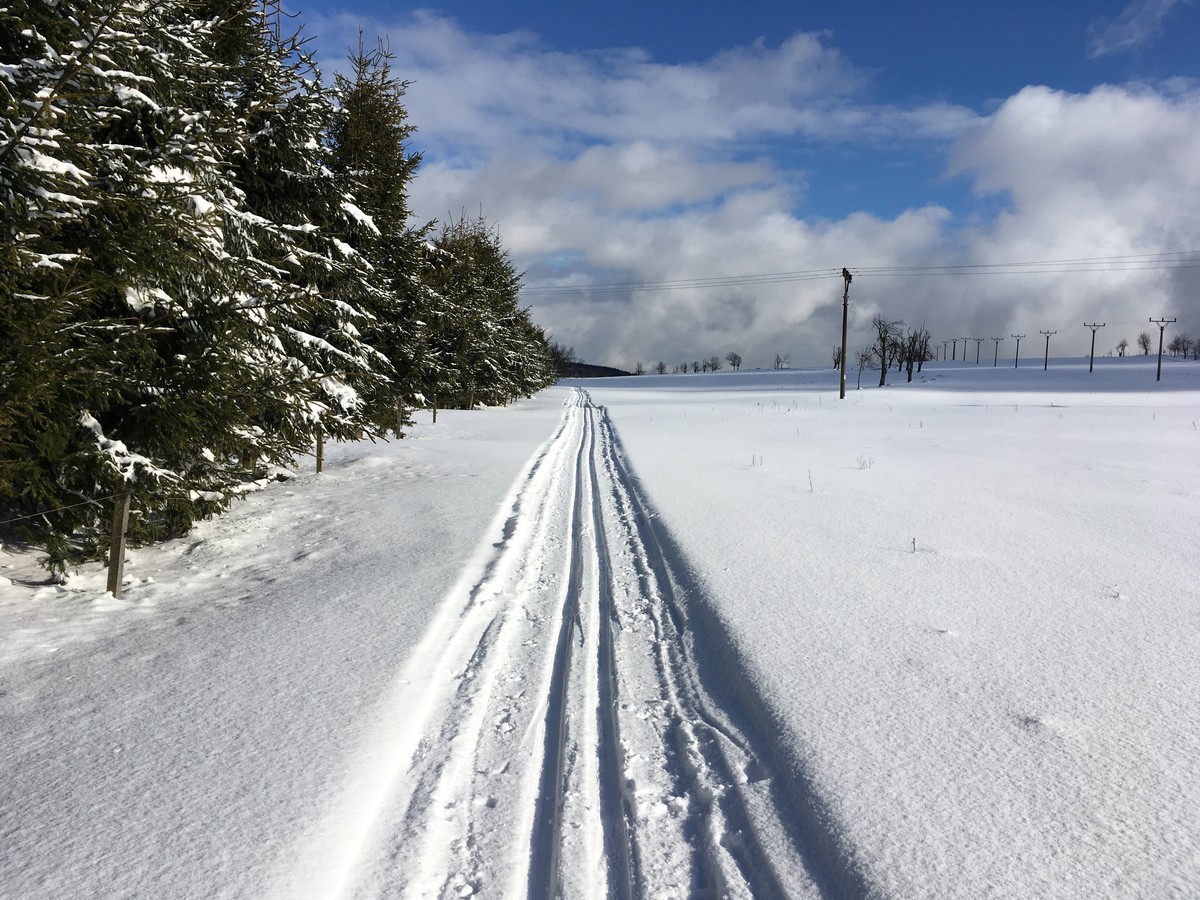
[{"left": 329, "top": 34, "right": 431, "bottom": 433}]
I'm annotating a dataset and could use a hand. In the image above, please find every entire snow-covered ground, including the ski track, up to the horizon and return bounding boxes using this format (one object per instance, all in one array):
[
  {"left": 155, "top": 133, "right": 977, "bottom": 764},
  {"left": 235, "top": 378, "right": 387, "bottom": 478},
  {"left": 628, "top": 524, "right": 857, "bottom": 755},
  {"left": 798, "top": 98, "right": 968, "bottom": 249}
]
[{"left": 0, "top": 358, "right": 1200, "bottom": 898}]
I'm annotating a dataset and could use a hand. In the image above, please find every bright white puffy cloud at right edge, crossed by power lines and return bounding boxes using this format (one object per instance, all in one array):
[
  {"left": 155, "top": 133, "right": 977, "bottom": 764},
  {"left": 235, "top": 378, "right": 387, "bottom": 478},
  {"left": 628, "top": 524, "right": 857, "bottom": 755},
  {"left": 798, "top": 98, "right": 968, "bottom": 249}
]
[{"left": 953, "top": 86, "right": 1200, "bottom": 324}]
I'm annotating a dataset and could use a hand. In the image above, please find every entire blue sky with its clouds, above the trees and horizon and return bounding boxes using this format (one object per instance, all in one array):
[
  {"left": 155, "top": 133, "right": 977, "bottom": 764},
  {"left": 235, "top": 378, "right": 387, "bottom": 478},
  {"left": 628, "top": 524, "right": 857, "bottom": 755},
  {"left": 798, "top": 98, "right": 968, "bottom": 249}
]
[{"left": 296, "top": 0, "right": 1200, "bottom": 366}]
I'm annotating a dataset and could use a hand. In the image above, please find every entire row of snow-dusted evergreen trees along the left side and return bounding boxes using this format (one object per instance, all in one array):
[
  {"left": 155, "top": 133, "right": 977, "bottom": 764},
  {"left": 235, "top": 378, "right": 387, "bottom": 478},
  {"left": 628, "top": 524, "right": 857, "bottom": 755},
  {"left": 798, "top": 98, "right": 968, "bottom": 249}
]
[{"left": 0, "top": 0, "right": 553, "bottom": 571}]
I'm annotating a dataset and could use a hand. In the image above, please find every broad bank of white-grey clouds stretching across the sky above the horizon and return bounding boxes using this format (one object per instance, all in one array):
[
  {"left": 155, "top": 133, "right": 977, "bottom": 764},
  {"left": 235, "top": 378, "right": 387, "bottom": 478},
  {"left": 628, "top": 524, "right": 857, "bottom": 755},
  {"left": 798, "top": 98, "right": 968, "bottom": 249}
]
[{"left": 308, "top": 13, "right": 1200, "bottom": 367}]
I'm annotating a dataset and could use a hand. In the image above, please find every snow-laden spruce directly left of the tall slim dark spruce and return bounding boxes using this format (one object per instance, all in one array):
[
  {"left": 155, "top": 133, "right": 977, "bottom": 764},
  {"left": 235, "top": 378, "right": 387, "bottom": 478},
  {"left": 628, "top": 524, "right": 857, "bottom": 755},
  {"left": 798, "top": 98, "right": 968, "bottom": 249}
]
[{"left": 224, "top": 14, "right": 391, "bottom": 446}]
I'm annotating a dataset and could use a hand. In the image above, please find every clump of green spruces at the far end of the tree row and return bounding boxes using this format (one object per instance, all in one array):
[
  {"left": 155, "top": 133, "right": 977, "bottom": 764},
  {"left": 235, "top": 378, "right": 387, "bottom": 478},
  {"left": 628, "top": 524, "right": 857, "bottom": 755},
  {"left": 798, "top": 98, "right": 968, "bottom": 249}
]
[{"left": 426, "top": 216, "right": 554, "bottom": 409}]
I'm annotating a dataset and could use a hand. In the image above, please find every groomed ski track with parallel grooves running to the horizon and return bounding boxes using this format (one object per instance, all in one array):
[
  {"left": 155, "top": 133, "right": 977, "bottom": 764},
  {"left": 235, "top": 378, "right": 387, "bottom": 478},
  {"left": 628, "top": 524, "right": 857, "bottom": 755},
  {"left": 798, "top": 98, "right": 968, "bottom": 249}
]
[{"left": 298, "top": 389, "right": 841, "bottom": 899}]
